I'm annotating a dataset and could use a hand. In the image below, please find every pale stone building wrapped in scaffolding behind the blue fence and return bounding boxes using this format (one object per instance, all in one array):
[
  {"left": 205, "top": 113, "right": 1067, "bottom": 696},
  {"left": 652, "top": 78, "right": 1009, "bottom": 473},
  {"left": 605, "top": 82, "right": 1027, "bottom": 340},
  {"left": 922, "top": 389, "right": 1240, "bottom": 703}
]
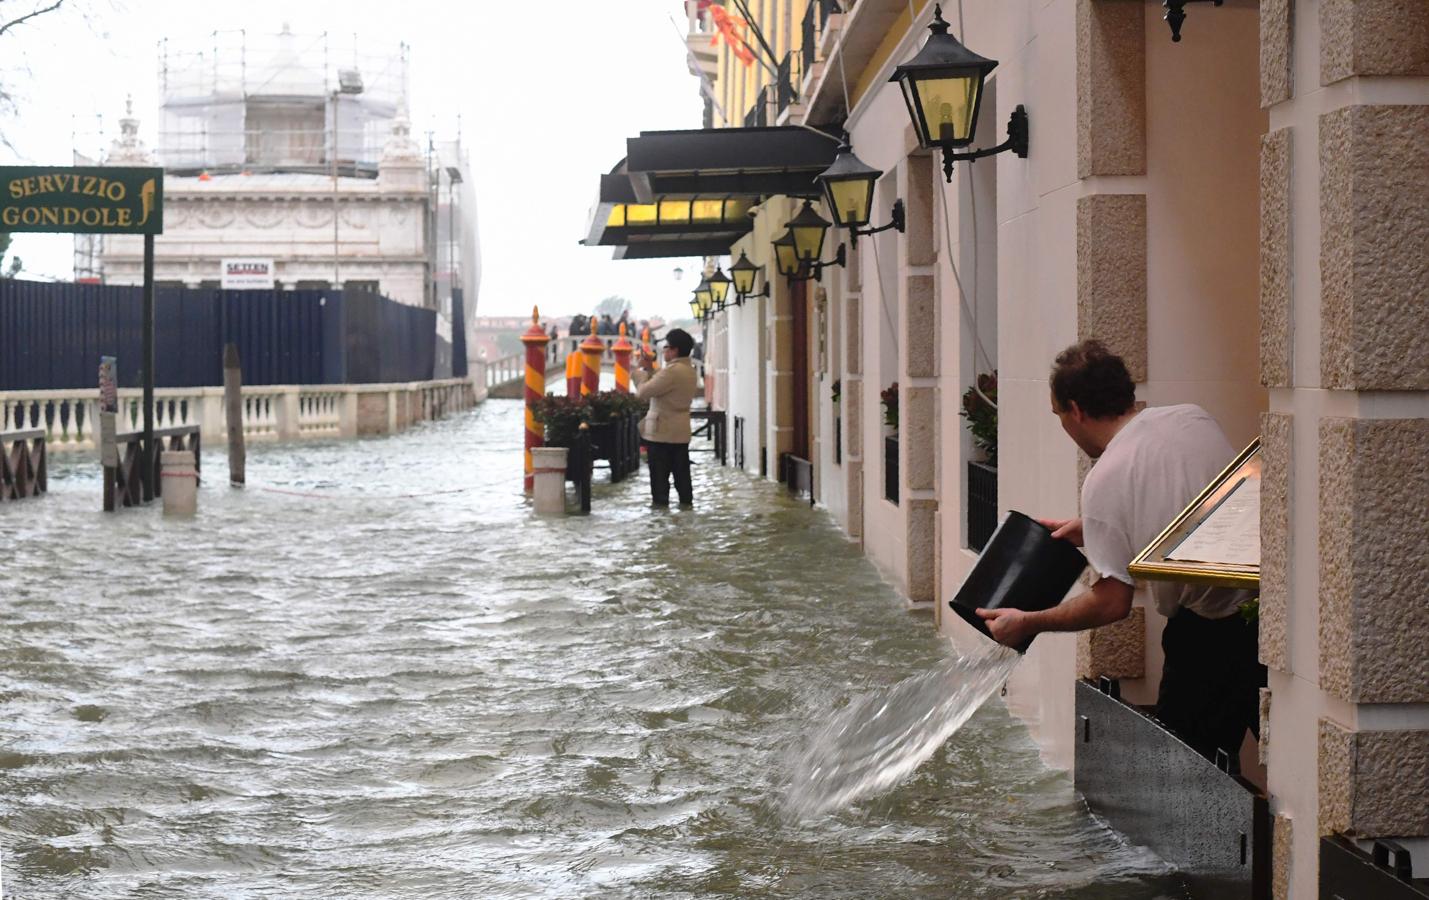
[{"left": 99, "top": 27, "right": 480, "bottom": 374}]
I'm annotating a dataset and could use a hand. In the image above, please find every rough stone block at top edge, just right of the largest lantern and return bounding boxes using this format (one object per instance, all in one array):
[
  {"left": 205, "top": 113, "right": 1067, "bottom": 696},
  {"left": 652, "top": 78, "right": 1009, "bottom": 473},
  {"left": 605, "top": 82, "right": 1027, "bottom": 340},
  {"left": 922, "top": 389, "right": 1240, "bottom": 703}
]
[{"left": 1076, "top": 0, "right": 1146, "bottom": 179}]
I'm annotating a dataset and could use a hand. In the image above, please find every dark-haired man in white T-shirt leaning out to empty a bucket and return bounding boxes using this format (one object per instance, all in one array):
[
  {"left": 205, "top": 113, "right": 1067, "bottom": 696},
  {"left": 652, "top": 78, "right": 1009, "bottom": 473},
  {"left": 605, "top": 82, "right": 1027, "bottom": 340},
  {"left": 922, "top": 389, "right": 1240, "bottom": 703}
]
[{"left": 979, "top": 340, "right": 1265, "bottom": 759}]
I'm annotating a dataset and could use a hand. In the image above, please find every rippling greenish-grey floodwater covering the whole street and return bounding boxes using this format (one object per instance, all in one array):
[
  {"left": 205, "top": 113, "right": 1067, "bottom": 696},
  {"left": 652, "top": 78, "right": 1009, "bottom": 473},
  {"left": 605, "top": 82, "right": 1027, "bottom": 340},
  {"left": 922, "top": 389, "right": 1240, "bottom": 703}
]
[{"left": 0, "top": 401, "right": 1179, "bottom": 900}]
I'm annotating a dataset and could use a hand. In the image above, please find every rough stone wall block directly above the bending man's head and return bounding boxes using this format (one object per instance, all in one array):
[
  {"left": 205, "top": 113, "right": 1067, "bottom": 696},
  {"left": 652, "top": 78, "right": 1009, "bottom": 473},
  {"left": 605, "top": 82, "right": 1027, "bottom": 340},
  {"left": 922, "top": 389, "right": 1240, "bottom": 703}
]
[{"left": 1076, "top": 194, "right": 1146, "bottom": 381}]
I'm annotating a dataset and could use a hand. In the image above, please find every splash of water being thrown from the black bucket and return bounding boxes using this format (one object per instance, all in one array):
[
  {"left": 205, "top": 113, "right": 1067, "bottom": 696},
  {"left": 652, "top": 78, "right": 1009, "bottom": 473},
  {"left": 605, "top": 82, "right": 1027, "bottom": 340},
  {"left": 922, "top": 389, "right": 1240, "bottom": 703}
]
[{"left": 785, "top": 641, "right": 1022, "bottom": 819}]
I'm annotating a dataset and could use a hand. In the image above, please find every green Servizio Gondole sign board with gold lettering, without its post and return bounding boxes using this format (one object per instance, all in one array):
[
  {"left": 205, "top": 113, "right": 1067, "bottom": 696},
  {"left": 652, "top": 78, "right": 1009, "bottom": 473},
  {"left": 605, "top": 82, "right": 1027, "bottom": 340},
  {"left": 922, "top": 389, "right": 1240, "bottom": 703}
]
[{"left": 0, "top": 166, "right": 164, "bottom": 234}]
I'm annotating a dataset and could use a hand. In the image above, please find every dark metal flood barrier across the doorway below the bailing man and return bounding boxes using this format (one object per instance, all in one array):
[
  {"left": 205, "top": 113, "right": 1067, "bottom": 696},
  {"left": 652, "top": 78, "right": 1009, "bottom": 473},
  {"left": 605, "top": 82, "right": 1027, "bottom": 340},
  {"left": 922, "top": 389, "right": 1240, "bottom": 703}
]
[{"left": 1076, "top": 681, "right": 1270, "bottom": 900}]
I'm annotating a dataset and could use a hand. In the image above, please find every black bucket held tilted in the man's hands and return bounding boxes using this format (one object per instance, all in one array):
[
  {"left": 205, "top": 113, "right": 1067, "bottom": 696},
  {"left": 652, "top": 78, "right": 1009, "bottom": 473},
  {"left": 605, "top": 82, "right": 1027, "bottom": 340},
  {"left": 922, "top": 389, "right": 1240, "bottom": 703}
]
[{"left": 947, "top": 511, "right": 1086, "bottom": 653}]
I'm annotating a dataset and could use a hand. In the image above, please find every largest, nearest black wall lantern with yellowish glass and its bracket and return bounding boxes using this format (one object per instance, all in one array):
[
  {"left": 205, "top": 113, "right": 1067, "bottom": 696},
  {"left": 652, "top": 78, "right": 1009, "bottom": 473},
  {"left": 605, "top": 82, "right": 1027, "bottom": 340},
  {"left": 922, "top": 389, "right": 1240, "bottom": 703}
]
[{"left": 889, "top": 4, "right": 1027, "bottom": 181}]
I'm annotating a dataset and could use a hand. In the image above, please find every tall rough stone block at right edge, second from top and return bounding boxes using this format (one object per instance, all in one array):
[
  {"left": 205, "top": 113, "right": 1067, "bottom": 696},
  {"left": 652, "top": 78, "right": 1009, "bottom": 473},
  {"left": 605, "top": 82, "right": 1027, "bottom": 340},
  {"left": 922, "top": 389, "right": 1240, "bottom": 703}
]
[{"left": 1320, "top": 106, "right": 1429, "bottom": 390}]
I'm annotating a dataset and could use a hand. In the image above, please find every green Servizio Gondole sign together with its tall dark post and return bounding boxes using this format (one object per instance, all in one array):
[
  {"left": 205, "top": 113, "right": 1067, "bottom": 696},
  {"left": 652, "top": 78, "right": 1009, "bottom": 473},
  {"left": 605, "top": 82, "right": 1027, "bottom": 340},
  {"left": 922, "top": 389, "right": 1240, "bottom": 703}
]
[{"left": 0, "top": 166, "right": 164, "bottom": 501}]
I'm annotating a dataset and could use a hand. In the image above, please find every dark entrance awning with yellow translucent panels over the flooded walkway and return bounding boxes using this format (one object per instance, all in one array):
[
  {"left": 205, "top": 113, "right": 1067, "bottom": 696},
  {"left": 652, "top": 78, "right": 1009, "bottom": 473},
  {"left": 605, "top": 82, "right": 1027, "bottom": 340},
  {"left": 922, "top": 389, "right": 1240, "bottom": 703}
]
[{"left": 582, "top": 127, "right": 839, "bottom": 259}]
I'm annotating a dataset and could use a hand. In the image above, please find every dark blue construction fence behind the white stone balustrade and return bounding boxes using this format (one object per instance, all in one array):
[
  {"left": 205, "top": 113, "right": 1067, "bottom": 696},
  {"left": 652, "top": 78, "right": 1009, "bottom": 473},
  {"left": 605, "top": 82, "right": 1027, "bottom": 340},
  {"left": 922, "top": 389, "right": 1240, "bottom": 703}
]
[{"left": 0, "top": 279, "right": 440, "bottom": 390}]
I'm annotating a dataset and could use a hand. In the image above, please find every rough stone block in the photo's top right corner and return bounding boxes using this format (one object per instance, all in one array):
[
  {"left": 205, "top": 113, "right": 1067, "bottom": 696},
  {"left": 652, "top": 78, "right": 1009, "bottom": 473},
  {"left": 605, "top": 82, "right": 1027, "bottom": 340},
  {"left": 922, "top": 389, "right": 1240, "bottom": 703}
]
[{"left": 1320, "top": 0, "right": 1429, "bottom": 84}]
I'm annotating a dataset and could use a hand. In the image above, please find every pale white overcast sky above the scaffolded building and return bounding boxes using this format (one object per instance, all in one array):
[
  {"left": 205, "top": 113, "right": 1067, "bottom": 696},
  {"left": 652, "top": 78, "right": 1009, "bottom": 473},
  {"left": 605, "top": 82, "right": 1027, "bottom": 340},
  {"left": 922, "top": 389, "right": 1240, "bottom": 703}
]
[{"left": 0, "top": 0, "right": 700, "bottom": 317}]
